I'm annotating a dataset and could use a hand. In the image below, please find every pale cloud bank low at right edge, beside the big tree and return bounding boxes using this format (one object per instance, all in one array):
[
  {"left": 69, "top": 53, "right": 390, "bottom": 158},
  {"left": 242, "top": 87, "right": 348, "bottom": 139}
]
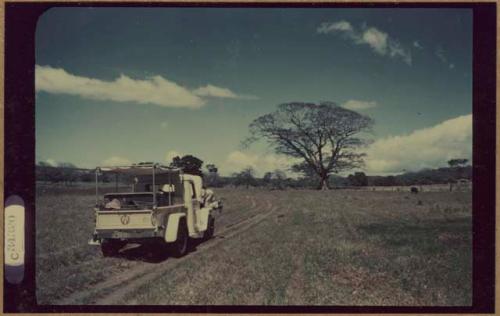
[{"left": 365, "top": 114, "right": 472, "bottom": 174}]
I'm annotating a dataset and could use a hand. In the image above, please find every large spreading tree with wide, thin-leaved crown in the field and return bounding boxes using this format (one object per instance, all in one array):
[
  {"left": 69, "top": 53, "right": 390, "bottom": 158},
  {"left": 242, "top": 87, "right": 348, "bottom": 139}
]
[{"left": 244, "top": 102, "right": 373, "bottom": 189}]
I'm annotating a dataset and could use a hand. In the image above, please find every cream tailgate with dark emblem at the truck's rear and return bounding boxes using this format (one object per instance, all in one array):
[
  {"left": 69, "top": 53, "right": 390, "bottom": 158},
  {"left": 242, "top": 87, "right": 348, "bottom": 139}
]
[{"left": 96, "top": 210, "right": 154, "bottom": 229}]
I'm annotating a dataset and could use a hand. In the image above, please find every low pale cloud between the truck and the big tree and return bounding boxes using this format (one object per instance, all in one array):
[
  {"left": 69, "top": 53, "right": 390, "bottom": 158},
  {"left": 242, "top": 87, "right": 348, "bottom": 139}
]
[{"left": 223, "top": 150, "right": 293, "bottom": 176}]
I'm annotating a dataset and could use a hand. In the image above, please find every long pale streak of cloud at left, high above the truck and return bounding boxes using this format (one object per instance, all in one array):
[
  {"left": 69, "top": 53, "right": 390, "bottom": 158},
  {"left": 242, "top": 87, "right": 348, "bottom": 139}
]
[{"left": 35, "top": 65, "right": 252, "bottom": 108}]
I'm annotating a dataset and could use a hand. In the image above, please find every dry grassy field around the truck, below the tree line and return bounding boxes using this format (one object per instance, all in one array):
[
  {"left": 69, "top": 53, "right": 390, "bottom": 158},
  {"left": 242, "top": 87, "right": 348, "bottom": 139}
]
[{"left": 37, "top": 188, "right": 472, "bottom": 306}]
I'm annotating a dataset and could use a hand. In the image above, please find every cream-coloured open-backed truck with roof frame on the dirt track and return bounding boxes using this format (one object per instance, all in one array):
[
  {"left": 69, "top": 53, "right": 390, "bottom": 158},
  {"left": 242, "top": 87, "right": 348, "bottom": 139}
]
[{"left": 89, "top": 163, "right": 222, "bottom": 257}]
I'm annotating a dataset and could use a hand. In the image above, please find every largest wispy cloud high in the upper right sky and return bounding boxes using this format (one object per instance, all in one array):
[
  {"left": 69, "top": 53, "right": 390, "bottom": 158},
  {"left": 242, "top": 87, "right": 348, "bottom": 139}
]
[{"left": 316, "top": 21, "right": 415, "bottom": 65}]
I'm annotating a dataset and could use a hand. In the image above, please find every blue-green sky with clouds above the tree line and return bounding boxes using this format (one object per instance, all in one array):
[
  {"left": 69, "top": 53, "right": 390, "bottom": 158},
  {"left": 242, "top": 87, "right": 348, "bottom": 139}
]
[{"left": 36, "top": 8, "right": 472, "bottom": 174}]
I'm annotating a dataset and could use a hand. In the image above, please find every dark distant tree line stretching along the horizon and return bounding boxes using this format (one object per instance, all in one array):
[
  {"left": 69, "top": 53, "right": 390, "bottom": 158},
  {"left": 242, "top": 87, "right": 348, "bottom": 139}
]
[{"left": 36, "top": 155, "right": 472, "bottom": 190}]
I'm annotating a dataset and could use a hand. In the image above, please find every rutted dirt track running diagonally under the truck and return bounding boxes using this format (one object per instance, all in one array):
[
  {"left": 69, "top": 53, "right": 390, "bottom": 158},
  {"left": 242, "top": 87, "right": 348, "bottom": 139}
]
[{"left": 54, "top": 197, "right": 276, "bottom": 305}]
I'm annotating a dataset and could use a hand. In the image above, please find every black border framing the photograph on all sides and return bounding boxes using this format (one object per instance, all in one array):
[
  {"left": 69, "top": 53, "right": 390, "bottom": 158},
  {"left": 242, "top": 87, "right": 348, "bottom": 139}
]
[{"left": 4, "top": 2, "right": 496, "bottom": 313}]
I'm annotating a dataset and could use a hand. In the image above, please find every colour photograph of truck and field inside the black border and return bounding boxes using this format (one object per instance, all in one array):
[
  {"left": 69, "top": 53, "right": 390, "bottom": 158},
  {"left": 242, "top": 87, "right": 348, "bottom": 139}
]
[{"left": 2, "top": 3, "right": 495, "bottom": 311}]
